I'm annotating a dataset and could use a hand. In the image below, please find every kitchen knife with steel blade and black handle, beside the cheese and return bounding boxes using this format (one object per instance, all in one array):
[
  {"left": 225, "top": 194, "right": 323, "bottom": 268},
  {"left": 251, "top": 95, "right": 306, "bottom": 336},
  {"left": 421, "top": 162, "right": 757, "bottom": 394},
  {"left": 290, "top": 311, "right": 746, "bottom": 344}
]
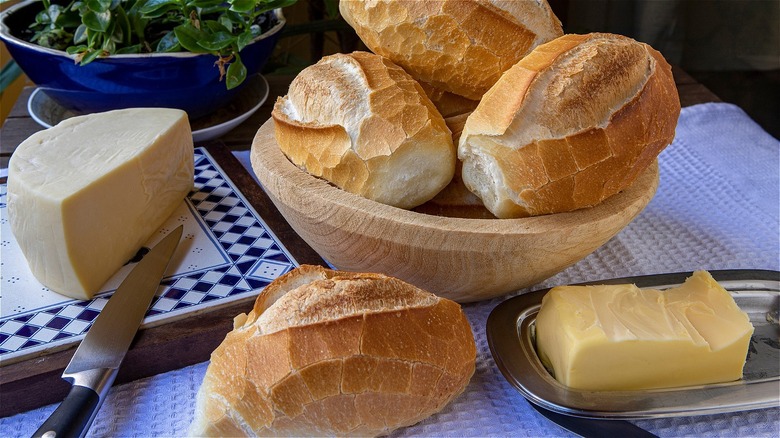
[{"left": 33, "top": 225, "right": 183, "bottom": 438}]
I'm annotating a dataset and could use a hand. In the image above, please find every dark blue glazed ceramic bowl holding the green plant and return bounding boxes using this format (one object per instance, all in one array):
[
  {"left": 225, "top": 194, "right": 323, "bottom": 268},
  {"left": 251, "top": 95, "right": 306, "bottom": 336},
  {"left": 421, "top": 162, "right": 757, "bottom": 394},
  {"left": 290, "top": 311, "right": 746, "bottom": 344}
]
[{"left": 0, "top": 0, "right": 285, "bottom": 119}]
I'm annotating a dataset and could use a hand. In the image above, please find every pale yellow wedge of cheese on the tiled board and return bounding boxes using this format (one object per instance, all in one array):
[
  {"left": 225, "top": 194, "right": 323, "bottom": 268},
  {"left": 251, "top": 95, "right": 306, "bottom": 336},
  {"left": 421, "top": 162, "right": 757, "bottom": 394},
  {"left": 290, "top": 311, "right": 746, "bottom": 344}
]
[{"left": 7, "top": 108, "right": 194, "bottom": 299}]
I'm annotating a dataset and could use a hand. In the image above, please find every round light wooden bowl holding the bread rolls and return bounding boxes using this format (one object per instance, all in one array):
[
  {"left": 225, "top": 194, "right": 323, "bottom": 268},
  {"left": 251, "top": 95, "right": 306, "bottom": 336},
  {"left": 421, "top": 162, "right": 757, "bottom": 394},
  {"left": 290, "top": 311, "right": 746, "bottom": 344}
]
[{"left": 252, "top": 119, "right": 658, "bottom": 302}]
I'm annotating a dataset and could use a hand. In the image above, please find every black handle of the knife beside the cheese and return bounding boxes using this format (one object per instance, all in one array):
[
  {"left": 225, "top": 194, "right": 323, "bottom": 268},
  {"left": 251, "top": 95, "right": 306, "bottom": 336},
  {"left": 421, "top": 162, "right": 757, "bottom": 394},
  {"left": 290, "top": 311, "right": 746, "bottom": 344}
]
[{"left": 33, "top": 385, "right": 100, "bottom": 438}]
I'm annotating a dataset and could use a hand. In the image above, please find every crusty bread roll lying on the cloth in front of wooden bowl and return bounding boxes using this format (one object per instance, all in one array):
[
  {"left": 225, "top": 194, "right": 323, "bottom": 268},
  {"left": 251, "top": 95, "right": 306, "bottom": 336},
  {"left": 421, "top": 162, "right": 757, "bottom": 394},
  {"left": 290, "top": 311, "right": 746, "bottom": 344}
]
[{"left": 189, "top": 265, "right": 476, "bottom": 436}]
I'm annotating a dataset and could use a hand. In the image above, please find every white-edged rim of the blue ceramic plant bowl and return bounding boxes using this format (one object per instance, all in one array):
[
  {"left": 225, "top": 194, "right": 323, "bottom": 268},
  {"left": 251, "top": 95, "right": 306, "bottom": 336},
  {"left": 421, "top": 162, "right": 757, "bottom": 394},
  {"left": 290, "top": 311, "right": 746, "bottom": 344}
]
[{"left": 0, "top": 0, "right": 287, "bottom": 62}]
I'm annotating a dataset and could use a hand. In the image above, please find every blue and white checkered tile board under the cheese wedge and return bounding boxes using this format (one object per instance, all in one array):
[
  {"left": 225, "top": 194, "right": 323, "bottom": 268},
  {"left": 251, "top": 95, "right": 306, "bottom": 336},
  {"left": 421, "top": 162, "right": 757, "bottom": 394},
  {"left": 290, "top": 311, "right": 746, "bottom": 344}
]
[{"left": 0, "top": 148, "right": 298, "bottom": 363}]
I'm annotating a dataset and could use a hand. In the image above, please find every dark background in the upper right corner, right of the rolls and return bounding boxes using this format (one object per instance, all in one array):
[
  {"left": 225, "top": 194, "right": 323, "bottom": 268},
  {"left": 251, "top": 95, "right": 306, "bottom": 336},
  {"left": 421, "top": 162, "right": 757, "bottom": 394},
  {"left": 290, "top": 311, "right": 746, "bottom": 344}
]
[{"left": 550, "top": 0, "right": 780, "bottom": 138}]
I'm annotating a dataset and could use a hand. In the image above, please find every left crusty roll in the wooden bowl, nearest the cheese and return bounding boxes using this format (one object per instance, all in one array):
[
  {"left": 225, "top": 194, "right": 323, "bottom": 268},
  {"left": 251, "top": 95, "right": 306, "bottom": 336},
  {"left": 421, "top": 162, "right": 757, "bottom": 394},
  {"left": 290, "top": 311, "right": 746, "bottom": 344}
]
[{"left": 272, "top": 52, "right": 456, "bottom": 209}]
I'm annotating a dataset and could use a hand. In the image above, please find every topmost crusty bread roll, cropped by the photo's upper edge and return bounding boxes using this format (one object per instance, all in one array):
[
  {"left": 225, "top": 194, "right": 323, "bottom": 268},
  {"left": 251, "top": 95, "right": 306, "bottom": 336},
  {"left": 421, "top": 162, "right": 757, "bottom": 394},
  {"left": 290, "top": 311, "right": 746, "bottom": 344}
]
[{"left": 339, "top": 0, "right": 563, "bottom": 100}]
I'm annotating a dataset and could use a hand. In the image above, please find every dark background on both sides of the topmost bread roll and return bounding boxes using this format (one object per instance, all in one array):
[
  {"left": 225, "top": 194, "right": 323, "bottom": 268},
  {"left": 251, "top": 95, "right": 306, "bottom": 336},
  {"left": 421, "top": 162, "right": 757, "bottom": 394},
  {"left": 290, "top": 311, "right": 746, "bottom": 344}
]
[{"left": 278, "top": 0, "right": 780, "bottom": 138}]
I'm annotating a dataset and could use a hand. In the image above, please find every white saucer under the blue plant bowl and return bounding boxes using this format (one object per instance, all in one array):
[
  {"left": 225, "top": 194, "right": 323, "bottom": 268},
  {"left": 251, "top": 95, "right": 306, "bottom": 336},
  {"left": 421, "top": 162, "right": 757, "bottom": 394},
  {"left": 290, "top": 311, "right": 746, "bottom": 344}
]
[{"left": 27, "top": 75, "right": 268, "bottom": 143}]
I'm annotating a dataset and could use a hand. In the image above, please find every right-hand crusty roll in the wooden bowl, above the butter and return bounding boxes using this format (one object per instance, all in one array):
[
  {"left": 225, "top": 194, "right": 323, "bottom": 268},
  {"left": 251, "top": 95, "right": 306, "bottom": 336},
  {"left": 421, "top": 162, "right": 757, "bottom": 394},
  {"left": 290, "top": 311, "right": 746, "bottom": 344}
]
[{"left": 458, "top": 34, "right": 680, "bottom": 218}]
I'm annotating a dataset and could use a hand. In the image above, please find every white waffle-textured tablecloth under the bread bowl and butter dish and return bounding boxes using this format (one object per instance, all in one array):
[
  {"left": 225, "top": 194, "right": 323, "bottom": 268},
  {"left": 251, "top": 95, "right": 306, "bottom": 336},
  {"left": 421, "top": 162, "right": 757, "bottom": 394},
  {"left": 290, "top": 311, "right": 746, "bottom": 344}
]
[{"left": 0, "top": 104, "right": 780, "bottom": 437}]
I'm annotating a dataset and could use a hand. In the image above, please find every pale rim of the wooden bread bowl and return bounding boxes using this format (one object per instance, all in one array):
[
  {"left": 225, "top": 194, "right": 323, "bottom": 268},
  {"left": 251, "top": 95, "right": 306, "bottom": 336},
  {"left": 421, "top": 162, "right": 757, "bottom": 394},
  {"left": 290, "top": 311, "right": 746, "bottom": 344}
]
[{"left": 251, "top": 117, "right": 659, "bottom": 238}]
